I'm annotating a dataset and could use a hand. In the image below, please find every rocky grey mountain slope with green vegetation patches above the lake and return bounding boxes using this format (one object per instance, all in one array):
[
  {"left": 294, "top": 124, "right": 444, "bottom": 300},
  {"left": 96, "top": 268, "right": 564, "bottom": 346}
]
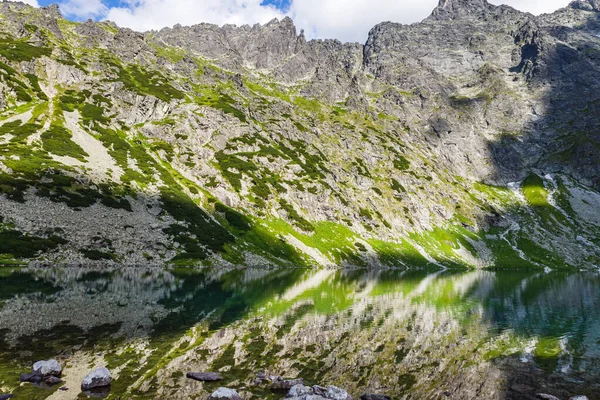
[{"left": 0, "top": 0, "right": 600, "bottom": 268}]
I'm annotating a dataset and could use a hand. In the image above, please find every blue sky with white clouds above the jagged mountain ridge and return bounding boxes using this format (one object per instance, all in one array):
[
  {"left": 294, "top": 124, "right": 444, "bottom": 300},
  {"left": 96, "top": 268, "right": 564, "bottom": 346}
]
[{"left": 28, "top": 0, "right": 569, "bottom": 43}]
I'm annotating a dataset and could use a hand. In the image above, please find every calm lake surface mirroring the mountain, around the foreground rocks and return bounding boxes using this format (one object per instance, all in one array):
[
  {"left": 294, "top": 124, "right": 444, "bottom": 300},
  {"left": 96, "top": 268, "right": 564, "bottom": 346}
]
[{"left": 0, "top": 268, "right": 600, "bottom": 400}]
